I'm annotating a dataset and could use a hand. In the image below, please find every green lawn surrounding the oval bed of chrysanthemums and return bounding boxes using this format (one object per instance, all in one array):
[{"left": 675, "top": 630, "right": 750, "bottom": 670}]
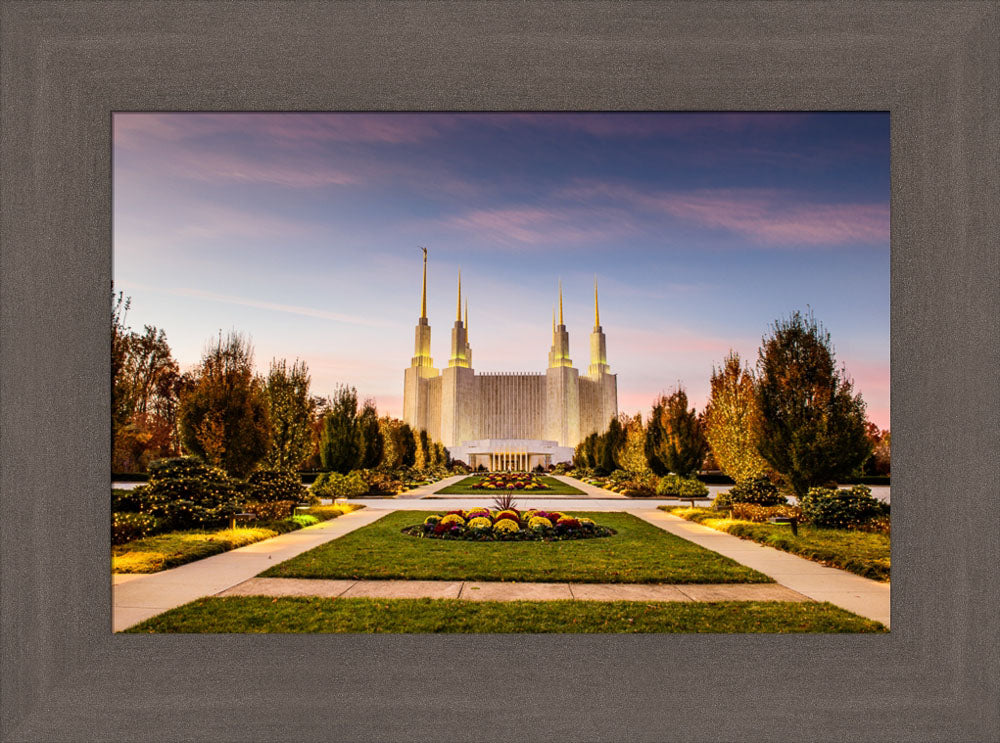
[{"left": 261, "top": 511, "right": 774, "bottom": 583}]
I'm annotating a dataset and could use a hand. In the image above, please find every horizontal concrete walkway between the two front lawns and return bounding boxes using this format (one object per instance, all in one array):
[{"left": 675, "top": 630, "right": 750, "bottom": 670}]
[{"left": 218, "top": 578, "right": 809, "bottom": 601}]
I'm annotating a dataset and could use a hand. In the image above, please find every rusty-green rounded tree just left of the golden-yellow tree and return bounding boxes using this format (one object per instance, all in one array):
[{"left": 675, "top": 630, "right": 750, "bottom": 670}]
[{"left": 646, "top": 386, "right": 708, "bottom": 477}]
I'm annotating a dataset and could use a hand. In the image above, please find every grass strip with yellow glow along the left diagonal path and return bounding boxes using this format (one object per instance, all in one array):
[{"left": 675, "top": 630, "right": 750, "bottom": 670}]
[{"left": 111, "top": 505, "right": 364, "bottom": 573}]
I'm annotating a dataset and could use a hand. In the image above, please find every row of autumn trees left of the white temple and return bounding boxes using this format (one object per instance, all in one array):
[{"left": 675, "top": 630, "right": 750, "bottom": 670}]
[{"left": 111, "top": 293, "right": 449, "bottom": 477}]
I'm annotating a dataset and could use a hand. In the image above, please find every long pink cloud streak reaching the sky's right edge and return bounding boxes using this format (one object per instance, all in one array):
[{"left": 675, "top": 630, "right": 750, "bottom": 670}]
[{"left": 559, "top": 183, "right": 889, "bottom": 246}]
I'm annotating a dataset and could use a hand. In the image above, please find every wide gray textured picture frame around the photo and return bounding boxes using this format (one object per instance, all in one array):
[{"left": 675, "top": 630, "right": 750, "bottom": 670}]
[{"left": 0, "top": 1, "right": 1000, "bottom": 742}]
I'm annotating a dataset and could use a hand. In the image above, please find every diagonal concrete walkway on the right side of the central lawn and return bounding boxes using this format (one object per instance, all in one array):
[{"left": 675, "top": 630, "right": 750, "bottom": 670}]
[{"left": 631, "top": 509, "right": 890, "bottom": 627}]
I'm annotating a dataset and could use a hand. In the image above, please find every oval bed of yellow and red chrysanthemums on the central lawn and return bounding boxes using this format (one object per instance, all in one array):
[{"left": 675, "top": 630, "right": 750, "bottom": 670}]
[{"left": 403, "top": 508, "right": 615, "bottom": 542}]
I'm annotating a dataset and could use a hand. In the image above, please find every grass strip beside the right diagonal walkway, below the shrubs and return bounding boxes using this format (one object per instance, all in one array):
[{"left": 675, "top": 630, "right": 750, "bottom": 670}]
[{"left": 660, "top": 506, "right": 891, "bottom": 581}]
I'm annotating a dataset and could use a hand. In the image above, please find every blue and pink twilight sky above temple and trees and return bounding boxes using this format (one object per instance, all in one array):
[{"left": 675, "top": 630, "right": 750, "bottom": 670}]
[{"left": 113, "top": 113, "right": 889, "bottom": 428}]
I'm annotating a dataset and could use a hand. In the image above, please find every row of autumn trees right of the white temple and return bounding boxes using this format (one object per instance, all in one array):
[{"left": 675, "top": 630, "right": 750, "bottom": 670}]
[{"left": 574, "top": 312, "right": 891, "bottom": 495}]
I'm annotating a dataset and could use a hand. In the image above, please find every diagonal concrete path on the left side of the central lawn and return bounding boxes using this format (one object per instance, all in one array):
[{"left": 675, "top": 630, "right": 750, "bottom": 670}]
[{"left": 111, "top": 508, "right": 386, "bottom": 632}]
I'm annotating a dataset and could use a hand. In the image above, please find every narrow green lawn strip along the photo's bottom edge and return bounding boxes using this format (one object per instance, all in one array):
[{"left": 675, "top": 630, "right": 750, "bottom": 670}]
[{"left": 126, "top": 596, "right": 885, "bottom": 633}]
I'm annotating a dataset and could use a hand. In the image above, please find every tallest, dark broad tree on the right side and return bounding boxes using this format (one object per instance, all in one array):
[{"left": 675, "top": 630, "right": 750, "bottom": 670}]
[{"left": 757, "top": 312, "right": 872, "bottom": 498}]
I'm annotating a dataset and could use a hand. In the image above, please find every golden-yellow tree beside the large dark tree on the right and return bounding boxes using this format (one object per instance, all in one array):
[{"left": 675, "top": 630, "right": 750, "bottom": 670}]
[{"left": 705, "top": 351, "right": 768, "bottom": 482}]
